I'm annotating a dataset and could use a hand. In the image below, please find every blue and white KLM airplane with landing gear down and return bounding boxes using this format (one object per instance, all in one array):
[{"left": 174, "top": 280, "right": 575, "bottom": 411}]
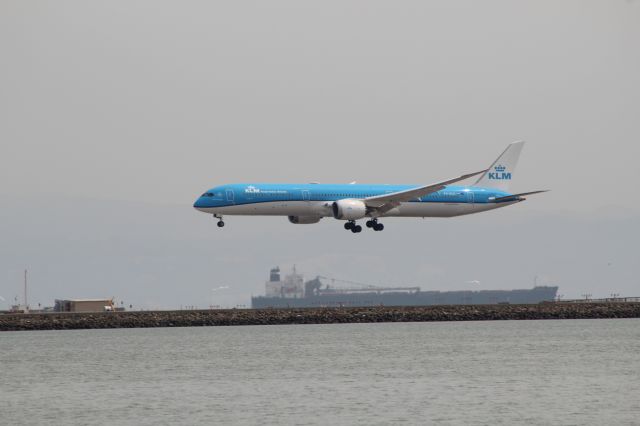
[{"left": 193, "top": 141, "right": 546, "bottom": 234}]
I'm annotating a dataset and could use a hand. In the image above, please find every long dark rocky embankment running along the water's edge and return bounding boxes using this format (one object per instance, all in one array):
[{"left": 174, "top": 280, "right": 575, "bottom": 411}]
[{"left": 0, "top": 303, "right": 640, "bottom": 331}]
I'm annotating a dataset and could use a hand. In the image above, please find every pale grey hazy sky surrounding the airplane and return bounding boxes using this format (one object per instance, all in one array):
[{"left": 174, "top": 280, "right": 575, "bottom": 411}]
[{"left": 0, "top": 0, "right": 640, "bottom": 309}]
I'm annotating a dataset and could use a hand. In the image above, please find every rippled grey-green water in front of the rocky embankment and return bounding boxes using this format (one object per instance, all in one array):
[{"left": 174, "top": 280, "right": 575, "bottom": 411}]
[{"left": 0, "top": 319, "right": 640, "bottom": 425}]
